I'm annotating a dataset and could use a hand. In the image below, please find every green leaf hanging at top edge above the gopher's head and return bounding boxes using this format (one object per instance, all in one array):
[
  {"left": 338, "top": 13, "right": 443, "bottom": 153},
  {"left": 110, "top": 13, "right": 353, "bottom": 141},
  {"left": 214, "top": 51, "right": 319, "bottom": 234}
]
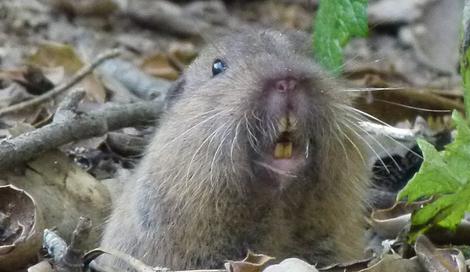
[{"left": 313, "top": 0, "right": 367, "bottom": 74}]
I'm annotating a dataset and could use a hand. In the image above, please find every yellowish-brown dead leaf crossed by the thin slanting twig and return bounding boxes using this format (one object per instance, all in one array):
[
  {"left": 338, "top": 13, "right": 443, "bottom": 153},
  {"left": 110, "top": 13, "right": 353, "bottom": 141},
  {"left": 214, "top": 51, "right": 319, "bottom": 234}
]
[{"left": 28, "top": 42, "right": 106, "bottom": 103}]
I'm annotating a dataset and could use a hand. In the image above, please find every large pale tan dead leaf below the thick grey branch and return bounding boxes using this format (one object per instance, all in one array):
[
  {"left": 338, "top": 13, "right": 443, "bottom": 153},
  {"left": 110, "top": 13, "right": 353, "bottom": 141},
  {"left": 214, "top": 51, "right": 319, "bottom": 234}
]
[{"left": 0, "top": 151, "right": 110, "bottom": 248}]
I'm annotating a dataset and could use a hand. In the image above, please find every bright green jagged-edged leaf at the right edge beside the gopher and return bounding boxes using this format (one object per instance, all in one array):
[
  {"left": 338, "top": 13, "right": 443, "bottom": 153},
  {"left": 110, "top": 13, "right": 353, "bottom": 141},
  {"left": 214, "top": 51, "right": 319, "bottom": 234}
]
[{"left": 398, "top": 111, "right": 470, "bottom": 237}]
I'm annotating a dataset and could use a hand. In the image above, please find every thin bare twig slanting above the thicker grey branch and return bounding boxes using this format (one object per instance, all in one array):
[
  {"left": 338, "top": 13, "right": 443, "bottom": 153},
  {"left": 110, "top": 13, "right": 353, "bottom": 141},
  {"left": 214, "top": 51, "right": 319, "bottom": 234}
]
[{"left": 0, "top": 50, "right": 119, "bottom": 117}]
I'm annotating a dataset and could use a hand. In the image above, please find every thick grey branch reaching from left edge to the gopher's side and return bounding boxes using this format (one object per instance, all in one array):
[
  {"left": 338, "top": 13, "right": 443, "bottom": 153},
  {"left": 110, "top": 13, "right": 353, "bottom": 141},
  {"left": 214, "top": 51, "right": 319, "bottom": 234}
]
[{"left": 0, "top": 101, "right": 163, "bottom": 169}]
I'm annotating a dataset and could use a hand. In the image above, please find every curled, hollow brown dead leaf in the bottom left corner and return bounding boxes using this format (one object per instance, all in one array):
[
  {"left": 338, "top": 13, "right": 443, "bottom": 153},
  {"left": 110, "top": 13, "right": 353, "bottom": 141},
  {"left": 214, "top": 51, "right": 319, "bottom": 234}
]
[{"left": 0, "top": 185, "right": 44, "bottom": 270}]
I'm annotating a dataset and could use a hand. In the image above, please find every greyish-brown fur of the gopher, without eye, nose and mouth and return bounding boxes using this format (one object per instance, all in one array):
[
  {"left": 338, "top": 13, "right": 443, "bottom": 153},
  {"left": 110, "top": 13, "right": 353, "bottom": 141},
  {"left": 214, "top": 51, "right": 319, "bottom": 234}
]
[{"left": 102, "top": 30, "right": 367, "bottom": 269}]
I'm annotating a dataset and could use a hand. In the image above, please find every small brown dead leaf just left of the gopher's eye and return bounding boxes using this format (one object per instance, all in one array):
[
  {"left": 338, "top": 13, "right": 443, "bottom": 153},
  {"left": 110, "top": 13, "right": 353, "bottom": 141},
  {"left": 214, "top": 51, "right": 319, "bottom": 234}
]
[{"left": 141, "top": 53, "right": 179, "bottom": 80}]
